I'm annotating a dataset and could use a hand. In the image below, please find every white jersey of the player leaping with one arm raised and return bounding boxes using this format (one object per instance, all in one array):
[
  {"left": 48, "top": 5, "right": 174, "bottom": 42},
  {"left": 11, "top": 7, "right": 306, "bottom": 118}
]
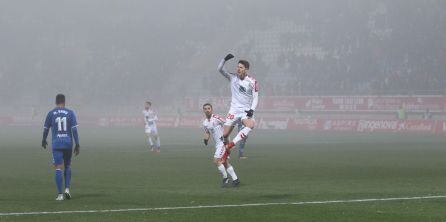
[{"left": 218, "top": 60, "right": 259, "bottom": 112}]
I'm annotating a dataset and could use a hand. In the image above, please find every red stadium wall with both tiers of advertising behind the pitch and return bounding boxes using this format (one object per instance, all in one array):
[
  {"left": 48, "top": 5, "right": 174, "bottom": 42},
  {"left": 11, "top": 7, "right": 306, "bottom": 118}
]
[{"left": 0, "top": 96, "right": 446, "bottom": 135}]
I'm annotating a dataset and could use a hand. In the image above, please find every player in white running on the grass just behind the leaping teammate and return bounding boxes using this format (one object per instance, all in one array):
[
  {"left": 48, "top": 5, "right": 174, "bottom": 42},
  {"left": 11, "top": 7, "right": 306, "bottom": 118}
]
[{"left": 203, "top": 103, "right": 240, "bottom": 187}]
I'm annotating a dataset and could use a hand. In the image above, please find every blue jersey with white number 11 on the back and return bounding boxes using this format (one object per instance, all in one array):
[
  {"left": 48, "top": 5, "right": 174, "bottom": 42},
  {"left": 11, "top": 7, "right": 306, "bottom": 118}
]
[{"left": 44, "top": 107, "right": 77, "bottom": 149}]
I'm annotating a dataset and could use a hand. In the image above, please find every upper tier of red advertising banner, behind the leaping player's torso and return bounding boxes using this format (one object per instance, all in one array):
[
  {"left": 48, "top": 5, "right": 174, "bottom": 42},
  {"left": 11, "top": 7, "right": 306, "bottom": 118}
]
[{"left": 194, "top": 96, "right": 446, "bottom": 112}]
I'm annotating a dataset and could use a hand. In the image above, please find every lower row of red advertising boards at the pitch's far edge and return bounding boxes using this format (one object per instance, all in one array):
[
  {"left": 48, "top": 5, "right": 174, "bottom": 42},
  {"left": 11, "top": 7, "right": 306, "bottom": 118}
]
[{"left": 0, "top": 115, "right": 446, "bottom": 135}]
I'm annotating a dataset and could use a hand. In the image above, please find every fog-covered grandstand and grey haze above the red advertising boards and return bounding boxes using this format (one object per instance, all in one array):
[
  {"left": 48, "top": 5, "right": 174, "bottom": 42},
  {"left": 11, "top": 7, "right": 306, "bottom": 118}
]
[{"left": 0, "top": 0, "right": 446, "bottom": 116}]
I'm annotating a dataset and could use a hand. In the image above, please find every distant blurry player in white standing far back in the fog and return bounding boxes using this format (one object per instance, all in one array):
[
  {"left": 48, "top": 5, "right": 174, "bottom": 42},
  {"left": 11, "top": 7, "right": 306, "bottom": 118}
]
[{"left": 142, "top": 101, "right": 161, "bottom": 153}]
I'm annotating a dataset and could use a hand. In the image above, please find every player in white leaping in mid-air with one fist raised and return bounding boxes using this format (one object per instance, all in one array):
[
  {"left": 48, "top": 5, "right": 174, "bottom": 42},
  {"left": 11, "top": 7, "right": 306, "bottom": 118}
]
[{"left": 218, "top": 54, "right": 259, "bottom": 158}]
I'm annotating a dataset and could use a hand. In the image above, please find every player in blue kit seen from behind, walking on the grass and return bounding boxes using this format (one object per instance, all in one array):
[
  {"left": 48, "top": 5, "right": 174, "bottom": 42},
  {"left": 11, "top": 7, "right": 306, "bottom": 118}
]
[{"left": 42, "top": 94, "right": 80, "bottom": 200}]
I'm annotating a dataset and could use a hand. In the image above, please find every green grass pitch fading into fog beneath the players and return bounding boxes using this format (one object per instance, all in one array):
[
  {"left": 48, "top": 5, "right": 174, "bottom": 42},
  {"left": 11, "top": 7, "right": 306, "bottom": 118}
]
[{"left": 0, "top": 127, "right": 446, "bottom": 221}]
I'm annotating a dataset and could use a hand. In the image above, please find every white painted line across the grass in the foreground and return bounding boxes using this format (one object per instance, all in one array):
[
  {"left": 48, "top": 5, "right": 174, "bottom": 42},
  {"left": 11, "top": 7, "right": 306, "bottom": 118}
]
[{"left": 0, "top": 195, "right": 446, "bottom": 216}]
